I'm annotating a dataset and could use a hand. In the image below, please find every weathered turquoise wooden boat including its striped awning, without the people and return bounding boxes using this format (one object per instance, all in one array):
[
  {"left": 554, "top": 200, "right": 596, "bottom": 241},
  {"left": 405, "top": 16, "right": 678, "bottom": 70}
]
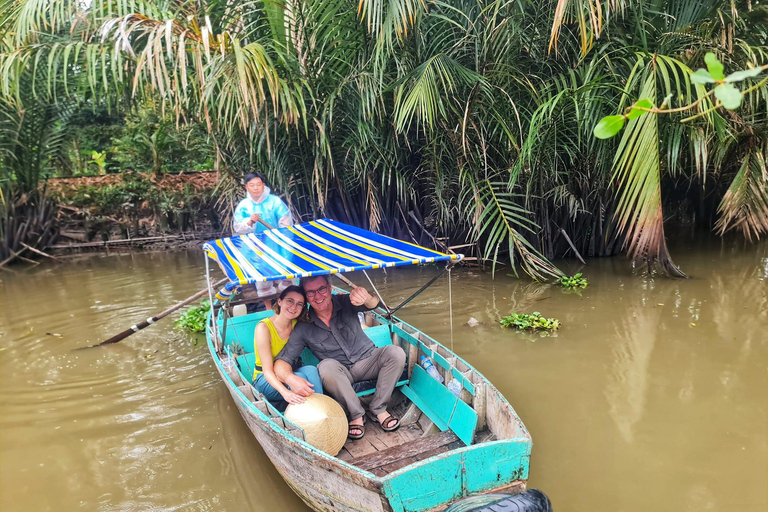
[{"left": 205, "top": 220, "right": 532, "bottom": 511}]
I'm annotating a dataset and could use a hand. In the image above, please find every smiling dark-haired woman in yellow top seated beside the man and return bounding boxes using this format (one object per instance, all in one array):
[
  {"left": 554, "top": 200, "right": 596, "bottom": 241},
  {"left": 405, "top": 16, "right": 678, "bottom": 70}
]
[{"left": 253, "top": 286, "right": 323, "bottom": 404}]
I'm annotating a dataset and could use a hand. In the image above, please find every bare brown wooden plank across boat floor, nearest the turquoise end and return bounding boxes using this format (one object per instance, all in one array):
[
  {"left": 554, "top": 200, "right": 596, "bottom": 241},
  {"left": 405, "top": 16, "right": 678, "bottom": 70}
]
[{"left": 348, "top": 430, "right": 464, "bottom": 476}]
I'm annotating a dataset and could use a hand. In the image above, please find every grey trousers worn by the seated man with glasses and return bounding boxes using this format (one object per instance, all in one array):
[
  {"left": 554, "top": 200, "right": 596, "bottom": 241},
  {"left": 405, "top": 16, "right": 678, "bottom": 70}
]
[{"left": 317, "top": 345, "right": 405, "bottom": 421}]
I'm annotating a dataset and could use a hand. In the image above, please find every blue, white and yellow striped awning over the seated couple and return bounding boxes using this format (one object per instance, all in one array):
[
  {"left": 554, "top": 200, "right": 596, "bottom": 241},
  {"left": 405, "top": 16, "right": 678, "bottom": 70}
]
[{"left": 203, "top": 219, "right": 463, "bottom": 298}]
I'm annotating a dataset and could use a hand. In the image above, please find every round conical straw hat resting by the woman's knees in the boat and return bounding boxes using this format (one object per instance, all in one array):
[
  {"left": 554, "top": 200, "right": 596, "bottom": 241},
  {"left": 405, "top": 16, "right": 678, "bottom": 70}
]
[{"left": 285, "top": 393, "right": 347, "bottom": 456}]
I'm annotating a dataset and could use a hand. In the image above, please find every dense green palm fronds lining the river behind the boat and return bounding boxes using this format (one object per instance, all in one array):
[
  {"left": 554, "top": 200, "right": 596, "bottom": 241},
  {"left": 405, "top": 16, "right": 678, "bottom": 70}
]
[{"left": 0, "top": 0, "right": 768, "bottom": 278}]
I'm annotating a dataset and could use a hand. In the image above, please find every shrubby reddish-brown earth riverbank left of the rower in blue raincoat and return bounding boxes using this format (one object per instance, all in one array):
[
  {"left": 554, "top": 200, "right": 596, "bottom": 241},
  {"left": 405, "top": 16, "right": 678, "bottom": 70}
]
[{"left": 46, "top": 171, "right": 226, "bottom": 254}]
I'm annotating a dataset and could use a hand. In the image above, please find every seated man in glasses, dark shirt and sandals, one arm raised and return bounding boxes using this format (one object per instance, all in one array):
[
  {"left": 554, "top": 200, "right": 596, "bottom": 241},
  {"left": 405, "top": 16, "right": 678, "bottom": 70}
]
[{"left": 275, "top": 276, "right": 405, "bottom": 439}]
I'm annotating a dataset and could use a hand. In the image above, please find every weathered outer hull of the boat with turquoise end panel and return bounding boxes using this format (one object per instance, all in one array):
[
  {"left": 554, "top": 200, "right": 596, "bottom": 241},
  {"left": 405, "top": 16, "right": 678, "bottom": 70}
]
[{"left": 208, "top": 314, "right": 531, "bottom": 512}]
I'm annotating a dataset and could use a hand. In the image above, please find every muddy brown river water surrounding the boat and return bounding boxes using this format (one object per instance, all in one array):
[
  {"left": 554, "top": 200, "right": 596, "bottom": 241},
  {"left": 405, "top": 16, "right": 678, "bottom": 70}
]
[{"left": 0, "top": 240, "right": 768, "bottom": 512}]
